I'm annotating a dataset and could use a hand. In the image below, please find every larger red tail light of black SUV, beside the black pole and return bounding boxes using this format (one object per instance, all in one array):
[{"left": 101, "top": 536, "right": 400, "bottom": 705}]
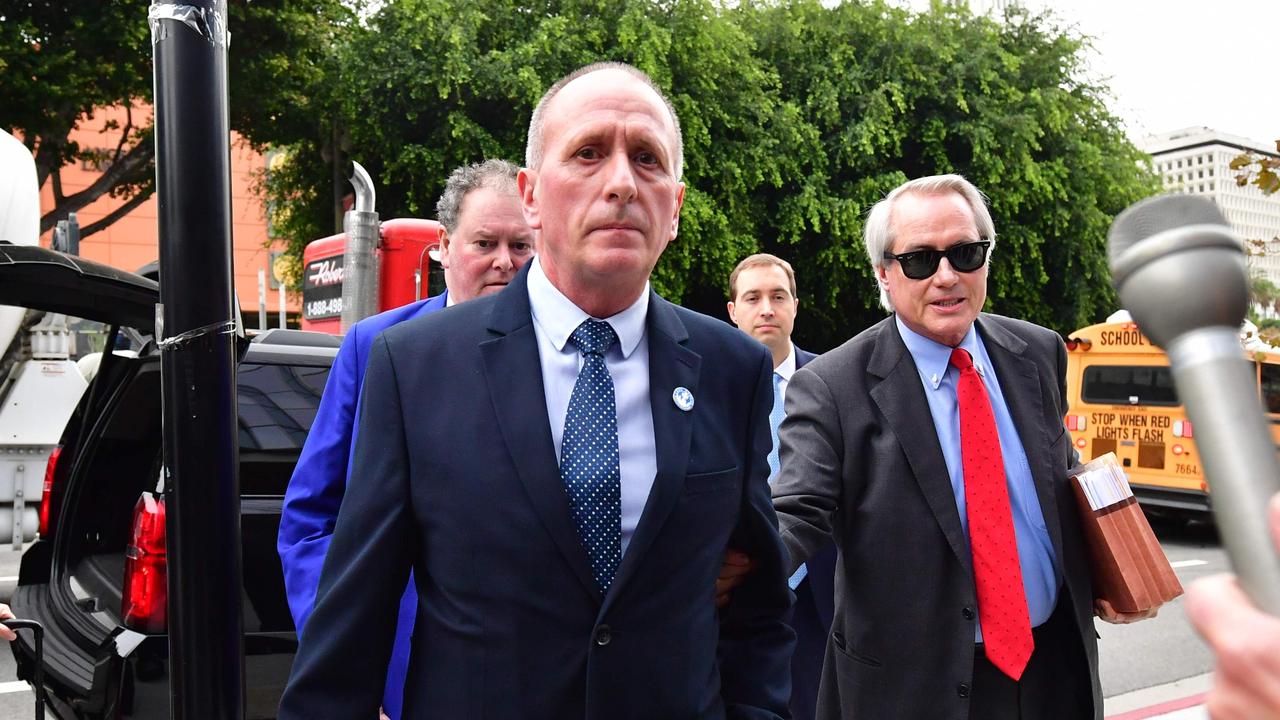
[{"left": 120, "top": 492, "right": 169, "bottom": 633}]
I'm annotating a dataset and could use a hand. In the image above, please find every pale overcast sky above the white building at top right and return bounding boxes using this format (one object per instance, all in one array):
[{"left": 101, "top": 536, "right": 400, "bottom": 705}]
[{"left": 1025, "top": 0, "right": 1280, "bottom": 143}]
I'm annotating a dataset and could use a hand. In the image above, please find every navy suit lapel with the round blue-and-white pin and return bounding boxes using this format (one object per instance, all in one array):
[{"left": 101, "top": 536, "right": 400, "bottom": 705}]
[{"left": 600, "top": 291, "right": 701, "bottom": 612}]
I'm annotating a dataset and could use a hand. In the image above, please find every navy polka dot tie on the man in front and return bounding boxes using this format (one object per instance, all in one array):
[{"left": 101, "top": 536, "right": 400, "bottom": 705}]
[{"left": 561, "top": 319, "right": 622, "bottom": 592}]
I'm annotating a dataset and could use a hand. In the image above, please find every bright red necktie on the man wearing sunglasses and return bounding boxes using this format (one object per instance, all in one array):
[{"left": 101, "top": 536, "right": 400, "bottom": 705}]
[{"left": 951, "top": 347, "right": 1036, "bottom": 680}]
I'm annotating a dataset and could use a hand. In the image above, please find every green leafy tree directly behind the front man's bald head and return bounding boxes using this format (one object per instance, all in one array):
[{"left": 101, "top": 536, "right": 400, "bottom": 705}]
[{"left": 266, "top": 0, "right": 808, "bottom": 304}]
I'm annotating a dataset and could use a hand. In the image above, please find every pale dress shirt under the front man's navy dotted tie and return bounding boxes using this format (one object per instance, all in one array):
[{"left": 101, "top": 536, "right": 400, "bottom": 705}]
[{"left": 529, "top": 258, "right": 655, "bottom": 555}]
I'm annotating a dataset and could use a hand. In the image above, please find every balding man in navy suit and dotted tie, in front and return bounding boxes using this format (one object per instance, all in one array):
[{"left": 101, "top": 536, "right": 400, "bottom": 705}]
[{"left": 280, "top": 63, "right": 792, "bottom": 720}]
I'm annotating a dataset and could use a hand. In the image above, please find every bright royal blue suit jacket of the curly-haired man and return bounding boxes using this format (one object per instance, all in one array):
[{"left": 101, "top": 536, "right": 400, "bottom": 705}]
[{"left": 276, "top": 292, "right": 447, "bottom": 720}]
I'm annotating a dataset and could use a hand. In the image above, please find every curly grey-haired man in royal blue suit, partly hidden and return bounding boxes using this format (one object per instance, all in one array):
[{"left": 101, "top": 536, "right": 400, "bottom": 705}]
[{"left": 278, "top": 160, "right": 534, "bottom": 719}]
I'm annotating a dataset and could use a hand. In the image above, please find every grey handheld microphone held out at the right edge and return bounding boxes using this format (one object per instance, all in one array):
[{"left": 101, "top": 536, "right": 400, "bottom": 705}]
[{"left": 1107, "top": 195, "right": 1280, "bottom": 615}]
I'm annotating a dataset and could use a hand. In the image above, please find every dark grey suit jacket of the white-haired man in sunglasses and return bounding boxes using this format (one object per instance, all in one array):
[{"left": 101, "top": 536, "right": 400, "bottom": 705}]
[{"left": 773, "top": 314, "right": 1102, "bottom": 720}]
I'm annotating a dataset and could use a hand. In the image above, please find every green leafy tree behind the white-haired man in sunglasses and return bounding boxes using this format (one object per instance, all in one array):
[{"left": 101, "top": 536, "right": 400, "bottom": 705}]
[{"left": 741, "top": 1, "right": 1157, "bottom": 343}]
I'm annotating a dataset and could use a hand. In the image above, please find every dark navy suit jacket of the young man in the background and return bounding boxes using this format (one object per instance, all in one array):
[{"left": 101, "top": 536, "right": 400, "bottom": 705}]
[{"left": 791, "top": 347, "right": 836, "bottom": 720}]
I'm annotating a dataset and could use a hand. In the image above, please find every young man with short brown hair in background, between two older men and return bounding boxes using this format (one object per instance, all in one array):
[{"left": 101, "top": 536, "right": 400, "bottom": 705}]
[{"left": 728, "top": 252, "right": 836, "bottom": 720}]
